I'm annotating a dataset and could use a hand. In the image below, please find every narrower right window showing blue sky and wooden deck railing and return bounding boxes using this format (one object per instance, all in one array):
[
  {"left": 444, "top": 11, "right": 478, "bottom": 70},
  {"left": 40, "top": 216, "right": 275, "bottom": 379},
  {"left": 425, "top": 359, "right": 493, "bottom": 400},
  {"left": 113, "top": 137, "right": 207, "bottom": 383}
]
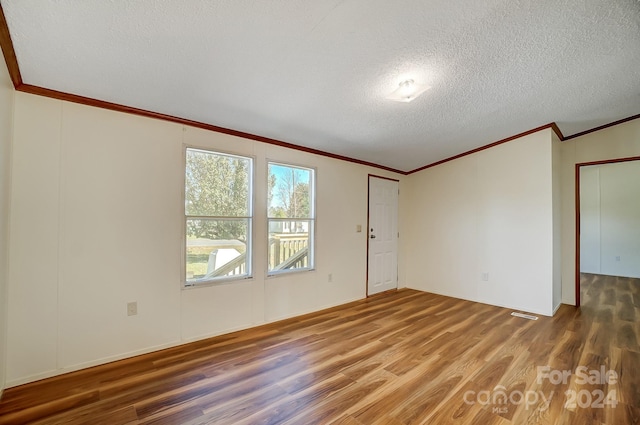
[{"left": 267, "top": 162, "right": 315, "bottom": 274}]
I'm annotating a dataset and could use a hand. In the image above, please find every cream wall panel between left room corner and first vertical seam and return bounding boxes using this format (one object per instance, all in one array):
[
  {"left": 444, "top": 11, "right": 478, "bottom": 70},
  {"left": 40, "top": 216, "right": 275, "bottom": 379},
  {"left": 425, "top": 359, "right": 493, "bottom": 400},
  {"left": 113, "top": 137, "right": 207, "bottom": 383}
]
[{"left": 7, "top": 93, "right": 62, "bottom": 384}]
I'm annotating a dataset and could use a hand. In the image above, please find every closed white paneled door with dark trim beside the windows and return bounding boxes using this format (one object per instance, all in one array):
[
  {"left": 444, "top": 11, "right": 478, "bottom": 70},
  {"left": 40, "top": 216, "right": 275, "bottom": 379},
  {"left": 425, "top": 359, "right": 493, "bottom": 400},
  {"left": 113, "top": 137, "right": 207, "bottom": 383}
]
[{"left": 367, "top": 176, "right": 398, "bottom": 295}]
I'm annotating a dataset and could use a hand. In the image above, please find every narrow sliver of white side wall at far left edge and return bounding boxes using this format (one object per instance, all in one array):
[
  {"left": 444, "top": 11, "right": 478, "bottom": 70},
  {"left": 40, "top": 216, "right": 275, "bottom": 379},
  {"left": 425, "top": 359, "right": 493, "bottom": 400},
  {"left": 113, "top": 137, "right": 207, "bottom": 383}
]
[{"left": 0, "top": 51, "right": 14, "bottom": 395}]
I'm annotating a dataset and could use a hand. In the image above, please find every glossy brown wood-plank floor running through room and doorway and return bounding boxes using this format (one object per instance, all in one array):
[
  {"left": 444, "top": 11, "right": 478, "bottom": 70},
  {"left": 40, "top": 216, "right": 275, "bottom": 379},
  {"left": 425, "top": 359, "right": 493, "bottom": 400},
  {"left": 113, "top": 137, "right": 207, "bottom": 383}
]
[{"left": 0, "top": 275, "right": 640, "bottom": 425}]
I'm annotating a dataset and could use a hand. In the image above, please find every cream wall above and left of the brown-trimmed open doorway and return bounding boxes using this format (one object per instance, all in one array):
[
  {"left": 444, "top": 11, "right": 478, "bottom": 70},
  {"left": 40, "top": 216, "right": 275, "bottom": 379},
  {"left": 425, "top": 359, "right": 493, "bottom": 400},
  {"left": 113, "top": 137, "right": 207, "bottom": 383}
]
[{"left": 561, "top": 119, "right": 640, "bottom": 305}]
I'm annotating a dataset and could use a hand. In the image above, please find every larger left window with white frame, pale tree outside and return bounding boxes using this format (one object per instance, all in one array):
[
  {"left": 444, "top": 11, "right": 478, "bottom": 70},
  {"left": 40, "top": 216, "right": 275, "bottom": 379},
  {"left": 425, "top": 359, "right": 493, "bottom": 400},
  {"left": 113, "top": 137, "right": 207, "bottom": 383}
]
[{"left": 184, "top": 148, "right": 253, "bottom": 286}]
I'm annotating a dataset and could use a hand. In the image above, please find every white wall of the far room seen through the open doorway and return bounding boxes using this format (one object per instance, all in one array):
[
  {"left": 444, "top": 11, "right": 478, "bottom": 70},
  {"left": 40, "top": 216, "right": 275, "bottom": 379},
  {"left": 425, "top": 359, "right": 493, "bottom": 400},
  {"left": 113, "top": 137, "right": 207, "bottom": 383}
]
[{"left": 580, "top": 161, "right": 640, "bottom": 278}]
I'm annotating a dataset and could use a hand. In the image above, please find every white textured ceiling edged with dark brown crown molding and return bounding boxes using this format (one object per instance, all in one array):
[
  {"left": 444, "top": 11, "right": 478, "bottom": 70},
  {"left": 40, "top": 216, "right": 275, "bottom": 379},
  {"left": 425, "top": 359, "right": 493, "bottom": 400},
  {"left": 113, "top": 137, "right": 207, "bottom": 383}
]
[{"left": 0, "top": 0, "right": 640, "bottom": 171}]
